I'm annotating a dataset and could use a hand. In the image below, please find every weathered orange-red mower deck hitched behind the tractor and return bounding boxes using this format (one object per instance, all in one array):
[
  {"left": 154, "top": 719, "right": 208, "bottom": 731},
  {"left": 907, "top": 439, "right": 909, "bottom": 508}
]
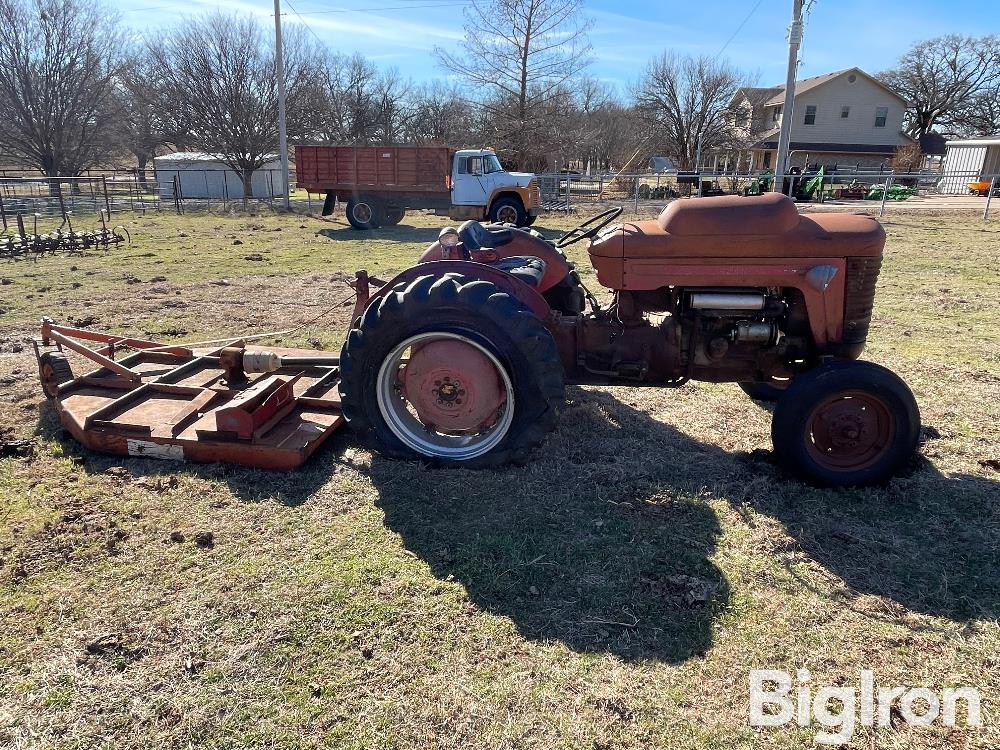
[{"left": 45, "top": 347, "right": 344, "bottom": 471}]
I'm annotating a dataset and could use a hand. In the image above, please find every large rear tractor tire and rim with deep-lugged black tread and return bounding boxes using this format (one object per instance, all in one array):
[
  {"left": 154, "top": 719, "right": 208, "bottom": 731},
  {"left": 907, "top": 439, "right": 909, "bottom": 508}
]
[{"left": 340, "top": 274, "right": 564, "bottom": 467}]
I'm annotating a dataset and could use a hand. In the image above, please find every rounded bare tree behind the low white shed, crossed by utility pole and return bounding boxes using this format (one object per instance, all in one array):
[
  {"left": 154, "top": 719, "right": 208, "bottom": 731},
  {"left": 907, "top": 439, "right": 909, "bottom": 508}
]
[{"left": 150, "top": 13, "right": 320, "bottom": 198}]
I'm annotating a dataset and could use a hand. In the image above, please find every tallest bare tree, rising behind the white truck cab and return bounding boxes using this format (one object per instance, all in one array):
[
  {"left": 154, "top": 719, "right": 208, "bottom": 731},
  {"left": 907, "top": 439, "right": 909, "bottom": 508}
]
[{"left": 435, "top": 0, "right": 591, "bottom": 167}]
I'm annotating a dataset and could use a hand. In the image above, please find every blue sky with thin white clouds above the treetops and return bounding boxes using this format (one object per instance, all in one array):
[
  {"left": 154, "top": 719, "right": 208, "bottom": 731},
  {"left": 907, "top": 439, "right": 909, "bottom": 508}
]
[{"left": 110, "top": 0, "right": 1000, "bottom": 90}]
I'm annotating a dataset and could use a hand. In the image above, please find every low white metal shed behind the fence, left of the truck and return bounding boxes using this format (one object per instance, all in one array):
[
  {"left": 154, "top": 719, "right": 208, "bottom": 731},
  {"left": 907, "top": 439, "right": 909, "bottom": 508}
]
[{"left": 153, "top": 151, "right": 285, "bottom": 200}]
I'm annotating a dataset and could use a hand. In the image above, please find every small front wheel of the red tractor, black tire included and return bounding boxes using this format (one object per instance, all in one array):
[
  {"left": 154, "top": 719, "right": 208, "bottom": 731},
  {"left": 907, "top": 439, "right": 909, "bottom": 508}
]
[{"left": 771, "top": 361, "right": 920, "bottom": 487}]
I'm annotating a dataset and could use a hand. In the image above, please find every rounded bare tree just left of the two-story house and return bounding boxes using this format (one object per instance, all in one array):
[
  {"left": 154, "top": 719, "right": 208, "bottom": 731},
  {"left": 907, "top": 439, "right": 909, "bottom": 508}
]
[{"left": 634, "top": 52, "right": 748, "bottom": 169}]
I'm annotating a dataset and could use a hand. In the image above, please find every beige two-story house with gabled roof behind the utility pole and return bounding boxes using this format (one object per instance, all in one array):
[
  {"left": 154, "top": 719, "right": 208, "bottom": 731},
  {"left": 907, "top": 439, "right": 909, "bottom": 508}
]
[{"left": 732, "top": 68, "right": 913, "bottom": 170}]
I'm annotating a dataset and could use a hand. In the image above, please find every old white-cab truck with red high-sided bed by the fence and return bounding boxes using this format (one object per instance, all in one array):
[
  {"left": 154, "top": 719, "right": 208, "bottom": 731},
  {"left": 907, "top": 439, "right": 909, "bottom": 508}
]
[{"left": 295, "top": 146, "right": 541, "bottom": 229}]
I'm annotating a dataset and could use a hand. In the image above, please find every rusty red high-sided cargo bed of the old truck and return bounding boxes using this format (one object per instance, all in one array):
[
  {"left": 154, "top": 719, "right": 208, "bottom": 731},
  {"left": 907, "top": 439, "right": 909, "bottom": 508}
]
[{"left": 295, "top": 146, "right": 455, "bottom": 193}]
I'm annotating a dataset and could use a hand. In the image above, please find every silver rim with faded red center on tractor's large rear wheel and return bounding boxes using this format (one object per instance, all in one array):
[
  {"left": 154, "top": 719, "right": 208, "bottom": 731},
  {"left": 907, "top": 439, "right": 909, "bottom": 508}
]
[{"left": 377, "top": 332, "right": 514, "bottom": 461}]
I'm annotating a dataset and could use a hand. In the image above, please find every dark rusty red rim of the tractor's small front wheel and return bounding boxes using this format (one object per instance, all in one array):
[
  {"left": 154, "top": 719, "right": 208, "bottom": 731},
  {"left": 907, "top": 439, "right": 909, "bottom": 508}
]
[{"left": 806, "top": 391, "right": 896, "bottom": 471}]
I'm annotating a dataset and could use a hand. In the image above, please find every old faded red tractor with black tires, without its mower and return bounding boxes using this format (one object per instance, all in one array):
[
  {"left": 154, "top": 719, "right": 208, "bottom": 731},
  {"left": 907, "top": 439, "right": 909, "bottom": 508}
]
[{"left": 340, "top": 193, "right": 920, "bottom": 486}]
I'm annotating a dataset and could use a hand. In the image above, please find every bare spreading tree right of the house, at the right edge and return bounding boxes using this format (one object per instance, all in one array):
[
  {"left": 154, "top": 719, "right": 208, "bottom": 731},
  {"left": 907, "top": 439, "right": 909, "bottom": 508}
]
[{"left": 878, "top": 34, "right": 1000, "bottom": 139}]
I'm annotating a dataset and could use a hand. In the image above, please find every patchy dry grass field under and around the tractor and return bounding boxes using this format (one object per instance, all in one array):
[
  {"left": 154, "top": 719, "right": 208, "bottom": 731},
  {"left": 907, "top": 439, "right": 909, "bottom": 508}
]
[{"left": 0, "top": 209, "right": 1000, "bottom": 750}]
